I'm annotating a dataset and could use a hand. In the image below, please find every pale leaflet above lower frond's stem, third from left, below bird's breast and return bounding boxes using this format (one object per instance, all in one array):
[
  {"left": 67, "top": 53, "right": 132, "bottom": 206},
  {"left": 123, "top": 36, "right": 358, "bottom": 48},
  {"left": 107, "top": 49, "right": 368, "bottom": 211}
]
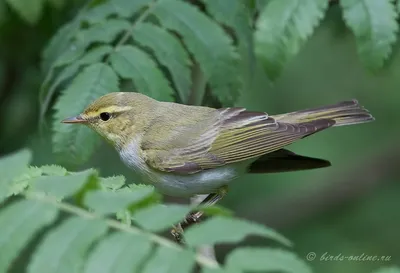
[{"left": 84, "top": 187, "right": 154, "bottom": 214}]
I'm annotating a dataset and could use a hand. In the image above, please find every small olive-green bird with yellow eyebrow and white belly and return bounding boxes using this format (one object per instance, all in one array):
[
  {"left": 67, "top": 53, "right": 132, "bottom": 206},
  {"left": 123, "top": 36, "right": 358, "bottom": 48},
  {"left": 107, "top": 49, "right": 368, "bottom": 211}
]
[{"left": 63, "top": 92, "right": 374, "bottom": 217}]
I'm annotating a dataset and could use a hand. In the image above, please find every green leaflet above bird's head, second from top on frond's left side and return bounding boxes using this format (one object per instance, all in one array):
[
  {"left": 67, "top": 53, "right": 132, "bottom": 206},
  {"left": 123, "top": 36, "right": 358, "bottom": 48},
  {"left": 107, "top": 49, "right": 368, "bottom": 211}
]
[{"left": 75, "top": 19, "right": 130, "bottom": 48}]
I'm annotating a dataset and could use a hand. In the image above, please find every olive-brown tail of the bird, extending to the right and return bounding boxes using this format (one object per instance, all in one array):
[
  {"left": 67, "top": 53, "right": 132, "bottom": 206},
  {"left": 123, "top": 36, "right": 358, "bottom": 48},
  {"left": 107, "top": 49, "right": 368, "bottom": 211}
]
[{"left": 273, "top": 100, "right": 374, "bottom": 126}]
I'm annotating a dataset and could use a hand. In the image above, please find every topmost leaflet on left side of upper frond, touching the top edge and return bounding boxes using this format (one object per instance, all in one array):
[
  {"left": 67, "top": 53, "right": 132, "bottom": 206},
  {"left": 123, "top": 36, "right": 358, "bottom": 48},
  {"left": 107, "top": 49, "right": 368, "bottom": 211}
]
[{"left": 84, "top": 0, "right": 153, "bottom": 23}]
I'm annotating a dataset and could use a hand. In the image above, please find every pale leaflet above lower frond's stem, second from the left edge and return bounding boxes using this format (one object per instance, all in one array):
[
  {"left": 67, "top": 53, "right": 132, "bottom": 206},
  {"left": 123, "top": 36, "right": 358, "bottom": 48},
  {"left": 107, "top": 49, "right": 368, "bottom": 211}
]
[{"left": 31, "top": 169, "right": 97, "bottom": 198}]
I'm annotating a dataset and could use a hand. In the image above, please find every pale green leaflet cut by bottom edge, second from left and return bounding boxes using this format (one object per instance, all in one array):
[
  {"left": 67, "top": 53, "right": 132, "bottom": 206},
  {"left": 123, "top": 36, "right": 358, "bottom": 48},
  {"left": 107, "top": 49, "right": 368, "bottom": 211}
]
[{"left": 28, "top": 217, "right": 107, "bottom": 273}]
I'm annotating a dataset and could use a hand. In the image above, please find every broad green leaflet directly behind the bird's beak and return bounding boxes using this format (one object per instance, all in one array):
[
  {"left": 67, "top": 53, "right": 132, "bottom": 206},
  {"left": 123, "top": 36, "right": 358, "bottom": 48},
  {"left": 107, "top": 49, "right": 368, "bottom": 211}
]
[{"left": 53, "top": 63, "right": 118, "bottom": 164}]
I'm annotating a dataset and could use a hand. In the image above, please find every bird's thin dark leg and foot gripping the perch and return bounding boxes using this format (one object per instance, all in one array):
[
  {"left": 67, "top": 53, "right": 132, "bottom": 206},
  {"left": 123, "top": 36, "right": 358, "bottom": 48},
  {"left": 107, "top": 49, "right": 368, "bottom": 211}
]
[{"left": 171, "top": 186, "right": 228, "bottom": 243}]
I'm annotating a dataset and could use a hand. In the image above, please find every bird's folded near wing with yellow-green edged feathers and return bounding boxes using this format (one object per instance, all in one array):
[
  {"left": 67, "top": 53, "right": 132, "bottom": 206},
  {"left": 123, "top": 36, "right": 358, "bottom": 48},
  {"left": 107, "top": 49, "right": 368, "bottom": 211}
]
[{"left": 143, "top": 108, "right": 335, "bottom": 174}]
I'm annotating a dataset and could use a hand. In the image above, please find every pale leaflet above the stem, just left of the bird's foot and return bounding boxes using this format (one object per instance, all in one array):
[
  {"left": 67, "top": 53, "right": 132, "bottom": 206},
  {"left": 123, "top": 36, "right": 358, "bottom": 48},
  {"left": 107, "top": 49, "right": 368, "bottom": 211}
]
[{"left": 132, "top": 204, "right": 190, "bottom": 232}]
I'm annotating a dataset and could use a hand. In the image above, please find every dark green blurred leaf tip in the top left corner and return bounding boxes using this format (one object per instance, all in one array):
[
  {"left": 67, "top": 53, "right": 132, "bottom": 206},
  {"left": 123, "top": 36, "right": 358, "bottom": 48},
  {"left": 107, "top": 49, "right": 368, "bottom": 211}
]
[{"left": 6, "top": 0, "right": 43, "bottom": 25}]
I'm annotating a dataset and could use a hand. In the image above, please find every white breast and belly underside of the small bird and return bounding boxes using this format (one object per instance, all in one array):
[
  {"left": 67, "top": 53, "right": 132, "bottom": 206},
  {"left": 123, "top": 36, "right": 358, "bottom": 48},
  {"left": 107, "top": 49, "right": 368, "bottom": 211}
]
[{"left": 120, "top": 138, "right": 237, "bottom": 196}]
